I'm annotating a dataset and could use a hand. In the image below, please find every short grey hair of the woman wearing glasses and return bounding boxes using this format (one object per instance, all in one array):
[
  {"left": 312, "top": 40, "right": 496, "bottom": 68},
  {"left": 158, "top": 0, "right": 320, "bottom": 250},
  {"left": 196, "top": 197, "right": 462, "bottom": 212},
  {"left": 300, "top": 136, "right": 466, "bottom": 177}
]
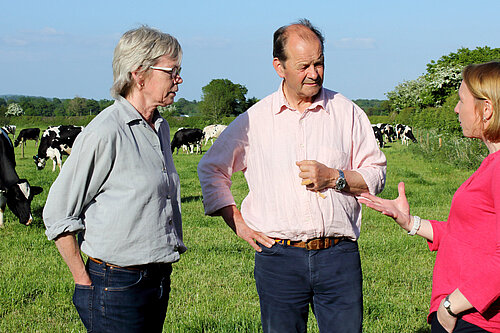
[{"left": 111, "top": 26, "right": 182, "bottom": 98}]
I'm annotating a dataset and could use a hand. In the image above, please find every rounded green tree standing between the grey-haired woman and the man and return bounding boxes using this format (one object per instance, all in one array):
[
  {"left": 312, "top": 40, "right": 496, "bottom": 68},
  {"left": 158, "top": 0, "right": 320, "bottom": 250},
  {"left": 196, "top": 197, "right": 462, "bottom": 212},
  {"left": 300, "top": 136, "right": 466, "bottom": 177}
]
[{"left": 200, "top": 79, "right": 248, "bottom": 122}]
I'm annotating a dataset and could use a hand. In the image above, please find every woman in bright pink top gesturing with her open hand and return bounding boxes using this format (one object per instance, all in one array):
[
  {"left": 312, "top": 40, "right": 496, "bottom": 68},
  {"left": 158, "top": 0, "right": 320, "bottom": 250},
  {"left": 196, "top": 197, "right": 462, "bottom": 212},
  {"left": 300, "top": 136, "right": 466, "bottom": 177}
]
[{"left": 359, "top": 62, "right": 500, "bottom": 332}]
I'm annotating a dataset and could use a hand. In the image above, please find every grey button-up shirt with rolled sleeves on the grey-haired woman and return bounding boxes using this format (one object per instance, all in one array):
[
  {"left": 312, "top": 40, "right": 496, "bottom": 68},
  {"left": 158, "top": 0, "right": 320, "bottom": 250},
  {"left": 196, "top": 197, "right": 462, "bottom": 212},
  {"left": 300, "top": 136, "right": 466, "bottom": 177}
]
[{"left": 43, "top": 98, "right": 186, "bottom": 266}]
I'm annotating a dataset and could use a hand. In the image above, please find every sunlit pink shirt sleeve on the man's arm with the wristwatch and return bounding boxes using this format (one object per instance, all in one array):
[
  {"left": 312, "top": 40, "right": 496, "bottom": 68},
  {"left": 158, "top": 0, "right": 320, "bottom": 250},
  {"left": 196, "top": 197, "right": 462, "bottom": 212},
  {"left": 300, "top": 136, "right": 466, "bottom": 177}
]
[{"left": 352, "top": 110, "right": 387, "bottom": 195}]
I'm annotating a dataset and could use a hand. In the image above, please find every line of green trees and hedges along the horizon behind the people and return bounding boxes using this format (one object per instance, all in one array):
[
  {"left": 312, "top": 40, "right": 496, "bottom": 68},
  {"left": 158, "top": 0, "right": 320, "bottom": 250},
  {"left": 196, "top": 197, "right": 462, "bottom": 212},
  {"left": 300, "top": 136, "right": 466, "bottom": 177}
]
[{"left": 12, "top": 46, "right": 500, "bottom": 128}]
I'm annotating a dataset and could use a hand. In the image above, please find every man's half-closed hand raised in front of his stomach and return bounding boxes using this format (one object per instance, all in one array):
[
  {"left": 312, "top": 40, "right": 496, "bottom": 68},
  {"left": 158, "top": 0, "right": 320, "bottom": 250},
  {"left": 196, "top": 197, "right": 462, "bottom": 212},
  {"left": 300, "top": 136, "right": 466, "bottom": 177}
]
[{"left": 296, "top": 160, "right": 339, "bottom": 192}]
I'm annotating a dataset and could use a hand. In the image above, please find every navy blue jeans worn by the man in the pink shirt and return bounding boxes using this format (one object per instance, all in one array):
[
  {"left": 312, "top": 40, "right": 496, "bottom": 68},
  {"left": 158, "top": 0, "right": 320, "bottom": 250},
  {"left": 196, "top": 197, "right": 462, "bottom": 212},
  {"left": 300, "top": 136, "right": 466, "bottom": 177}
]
[{"left": 254, "top": 240, "right": 363, "bottom": 333}]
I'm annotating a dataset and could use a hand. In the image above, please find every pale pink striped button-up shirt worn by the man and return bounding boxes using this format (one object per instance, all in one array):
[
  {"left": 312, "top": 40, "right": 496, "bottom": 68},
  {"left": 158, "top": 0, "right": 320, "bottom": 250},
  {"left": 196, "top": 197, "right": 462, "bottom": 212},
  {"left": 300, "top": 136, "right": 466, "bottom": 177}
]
[{"left": 198, "top": 85, "right": 387, "bottom": 241}]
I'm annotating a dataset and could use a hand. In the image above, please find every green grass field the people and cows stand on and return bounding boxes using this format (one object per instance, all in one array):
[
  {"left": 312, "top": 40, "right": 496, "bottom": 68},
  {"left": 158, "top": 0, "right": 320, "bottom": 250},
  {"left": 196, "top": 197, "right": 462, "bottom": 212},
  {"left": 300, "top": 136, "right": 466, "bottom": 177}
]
[{"left": 0, "top": 129, "right": 472, "bottom": 333}]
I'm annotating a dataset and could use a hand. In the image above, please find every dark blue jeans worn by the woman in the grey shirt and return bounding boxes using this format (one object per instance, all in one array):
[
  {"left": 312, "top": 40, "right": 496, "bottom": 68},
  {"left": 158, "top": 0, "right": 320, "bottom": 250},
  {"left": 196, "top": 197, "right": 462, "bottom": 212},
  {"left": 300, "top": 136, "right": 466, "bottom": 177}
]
[{"left": 73, "top": 260, "right": 172, "bottom": 332}]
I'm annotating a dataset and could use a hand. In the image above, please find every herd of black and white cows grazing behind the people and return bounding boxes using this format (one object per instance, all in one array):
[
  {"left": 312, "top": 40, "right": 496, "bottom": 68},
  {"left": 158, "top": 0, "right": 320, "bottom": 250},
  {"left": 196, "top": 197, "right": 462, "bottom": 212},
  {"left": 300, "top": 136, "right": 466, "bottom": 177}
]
[{"left": 0, "top": 124, "right": 417, "bottom": 227}]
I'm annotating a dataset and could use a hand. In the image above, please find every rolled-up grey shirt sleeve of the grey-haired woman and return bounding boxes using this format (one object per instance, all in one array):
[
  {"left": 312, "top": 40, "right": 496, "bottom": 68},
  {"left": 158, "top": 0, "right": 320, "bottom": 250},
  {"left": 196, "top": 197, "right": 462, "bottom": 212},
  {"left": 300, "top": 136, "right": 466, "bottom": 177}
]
[{"left": 43, "top": 131, "right": 113, "bottom": 240}]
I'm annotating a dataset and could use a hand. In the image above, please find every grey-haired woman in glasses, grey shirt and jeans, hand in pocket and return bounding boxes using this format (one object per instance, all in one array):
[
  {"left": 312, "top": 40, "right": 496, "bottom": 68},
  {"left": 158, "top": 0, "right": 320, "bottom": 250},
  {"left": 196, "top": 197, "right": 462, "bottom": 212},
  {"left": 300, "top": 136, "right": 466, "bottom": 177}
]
[{"left": 43, "top": 26, "right": 186, "bottom": 332}]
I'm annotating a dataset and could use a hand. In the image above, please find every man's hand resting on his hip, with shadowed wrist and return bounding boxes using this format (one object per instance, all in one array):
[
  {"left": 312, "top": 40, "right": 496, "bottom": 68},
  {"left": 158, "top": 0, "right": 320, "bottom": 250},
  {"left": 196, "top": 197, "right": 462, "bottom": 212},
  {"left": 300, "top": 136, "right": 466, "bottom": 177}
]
[{"left": 215, "top": 206, "right": 274, "bottom": 252}]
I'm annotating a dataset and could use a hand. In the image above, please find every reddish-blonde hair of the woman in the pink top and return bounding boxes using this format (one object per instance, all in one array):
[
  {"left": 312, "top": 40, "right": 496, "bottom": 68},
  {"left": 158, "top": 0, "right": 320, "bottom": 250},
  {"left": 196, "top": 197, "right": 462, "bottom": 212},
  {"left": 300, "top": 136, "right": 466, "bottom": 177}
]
[{"left": 462, "top": 61, "right": 500, "bottom": 142}]
